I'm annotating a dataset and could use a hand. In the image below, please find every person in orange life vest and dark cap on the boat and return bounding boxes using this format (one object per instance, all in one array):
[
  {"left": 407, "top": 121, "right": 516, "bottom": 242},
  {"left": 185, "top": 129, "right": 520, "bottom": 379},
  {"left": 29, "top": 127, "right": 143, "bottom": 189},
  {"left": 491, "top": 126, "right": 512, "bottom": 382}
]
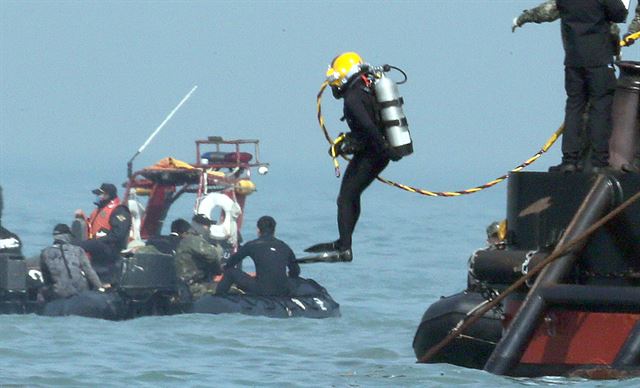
[{"left": 76, "top": 183, "right": 131, "bottom": 284}]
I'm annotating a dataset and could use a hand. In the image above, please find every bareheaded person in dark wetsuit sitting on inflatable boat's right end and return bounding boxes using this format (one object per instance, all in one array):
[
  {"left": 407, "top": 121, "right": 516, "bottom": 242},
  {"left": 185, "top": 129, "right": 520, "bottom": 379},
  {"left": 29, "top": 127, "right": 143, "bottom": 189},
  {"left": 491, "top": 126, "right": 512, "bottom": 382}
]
[{"left": 216, "top": 216, "right": 300, "bottom": 296}]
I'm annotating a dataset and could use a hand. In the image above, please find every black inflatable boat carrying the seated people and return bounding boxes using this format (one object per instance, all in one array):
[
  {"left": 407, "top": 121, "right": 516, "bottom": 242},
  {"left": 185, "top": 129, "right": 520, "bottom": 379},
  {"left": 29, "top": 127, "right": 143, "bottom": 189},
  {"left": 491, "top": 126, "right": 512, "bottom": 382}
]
[{"left": 0, "top": 253, "right": 340, "bottom": 320}]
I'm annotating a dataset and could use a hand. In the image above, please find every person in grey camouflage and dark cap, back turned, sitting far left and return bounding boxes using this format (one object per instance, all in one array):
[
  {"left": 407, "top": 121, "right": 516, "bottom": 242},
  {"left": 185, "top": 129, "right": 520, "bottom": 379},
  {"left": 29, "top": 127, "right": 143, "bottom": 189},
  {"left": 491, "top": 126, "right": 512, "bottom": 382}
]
[{"left": 40, "top": 224, "right": 104, "bottom": 300}]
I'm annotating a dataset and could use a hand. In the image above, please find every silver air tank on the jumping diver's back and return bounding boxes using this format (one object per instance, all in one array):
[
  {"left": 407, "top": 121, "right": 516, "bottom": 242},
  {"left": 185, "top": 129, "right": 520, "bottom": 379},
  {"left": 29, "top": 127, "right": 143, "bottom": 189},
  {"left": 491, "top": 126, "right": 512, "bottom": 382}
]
[{"left": 375, "top": 73, "right": 413, "bottom": 156}]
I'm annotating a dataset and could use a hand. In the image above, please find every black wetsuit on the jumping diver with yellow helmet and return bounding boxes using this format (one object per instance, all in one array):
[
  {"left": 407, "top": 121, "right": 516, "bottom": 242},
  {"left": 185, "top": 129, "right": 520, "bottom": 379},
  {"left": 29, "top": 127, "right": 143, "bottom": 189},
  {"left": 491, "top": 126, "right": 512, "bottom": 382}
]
[{"left": 338, "top": 76, "right": 390, "bottom": 250}]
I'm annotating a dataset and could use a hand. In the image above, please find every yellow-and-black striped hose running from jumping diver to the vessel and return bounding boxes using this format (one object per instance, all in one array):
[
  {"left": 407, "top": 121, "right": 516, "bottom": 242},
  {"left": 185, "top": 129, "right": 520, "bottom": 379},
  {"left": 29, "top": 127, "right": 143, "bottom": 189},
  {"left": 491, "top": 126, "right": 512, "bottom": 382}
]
[{"left": 316, "top": 81, "right": 564, "bottom": 197}]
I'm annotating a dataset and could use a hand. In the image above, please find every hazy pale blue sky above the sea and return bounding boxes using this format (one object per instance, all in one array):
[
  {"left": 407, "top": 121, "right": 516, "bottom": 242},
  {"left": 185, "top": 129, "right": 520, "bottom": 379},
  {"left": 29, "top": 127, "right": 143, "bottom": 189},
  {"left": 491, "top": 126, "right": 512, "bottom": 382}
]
[{"left": 0, "top": 0, "right": 640, "bottom": 190}]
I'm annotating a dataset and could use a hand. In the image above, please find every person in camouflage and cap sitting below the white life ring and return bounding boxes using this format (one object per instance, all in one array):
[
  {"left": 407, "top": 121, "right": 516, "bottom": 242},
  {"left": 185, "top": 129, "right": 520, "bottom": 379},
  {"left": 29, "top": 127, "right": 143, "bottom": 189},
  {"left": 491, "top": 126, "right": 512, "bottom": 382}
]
[{"left": 175, "top": 214, "right": 223, "bottom": 299}]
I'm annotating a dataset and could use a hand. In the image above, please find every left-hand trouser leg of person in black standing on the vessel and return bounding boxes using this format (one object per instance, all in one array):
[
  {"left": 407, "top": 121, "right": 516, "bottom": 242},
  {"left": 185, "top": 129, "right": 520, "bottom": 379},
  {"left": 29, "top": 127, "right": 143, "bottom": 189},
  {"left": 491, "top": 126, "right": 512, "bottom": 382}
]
[{"left": 562, "top": 66, "right": 592, "bottom": 165}]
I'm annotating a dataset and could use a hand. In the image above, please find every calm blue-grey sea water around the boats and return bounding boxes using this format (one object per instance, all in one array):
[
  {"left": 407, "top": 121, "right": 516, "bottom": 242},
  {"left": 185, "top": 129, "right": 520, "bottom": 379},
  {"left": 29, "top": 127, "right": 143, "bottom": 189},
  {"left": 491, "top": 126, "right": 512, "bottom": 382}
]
[{"left": 0, "top": 173, "right": 640, "bottom": 387}]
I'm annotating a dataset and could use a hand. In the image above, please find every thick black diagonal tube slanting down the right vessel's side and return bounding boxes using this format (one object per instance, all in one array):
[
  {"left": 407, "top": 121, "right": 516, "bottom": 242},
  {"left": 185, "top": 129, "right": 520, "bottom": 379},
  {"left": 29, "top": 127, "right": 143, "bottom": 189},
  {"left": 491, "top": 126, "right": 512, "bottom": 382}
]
[{"left": 484, "top": 175, "right": 617, "bottom": 375}]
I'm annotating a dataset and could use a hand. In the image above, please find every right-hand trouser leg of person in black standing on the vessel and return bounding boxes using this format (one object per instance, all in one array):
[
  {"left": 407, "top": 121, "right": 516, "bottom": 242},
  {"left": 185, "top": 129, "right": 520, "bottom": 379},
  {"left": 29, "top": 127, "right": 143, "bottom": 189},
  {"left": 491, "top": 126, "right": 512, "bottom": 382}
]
[{"left": 586, "top": 66, "right": 616, "bottom": 167}]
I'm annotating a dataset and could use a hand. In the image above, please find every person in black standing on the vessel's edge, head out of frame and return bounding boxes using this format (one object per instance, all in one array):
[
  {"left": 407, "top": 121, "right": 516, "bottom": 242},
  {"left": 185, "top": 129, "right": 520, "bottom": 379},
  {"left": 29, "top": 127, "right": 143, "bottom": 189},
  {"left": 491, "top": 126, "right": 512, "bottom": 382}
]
[{"left": 552, "top": 0, "right": 627, "bottom": 173}]
